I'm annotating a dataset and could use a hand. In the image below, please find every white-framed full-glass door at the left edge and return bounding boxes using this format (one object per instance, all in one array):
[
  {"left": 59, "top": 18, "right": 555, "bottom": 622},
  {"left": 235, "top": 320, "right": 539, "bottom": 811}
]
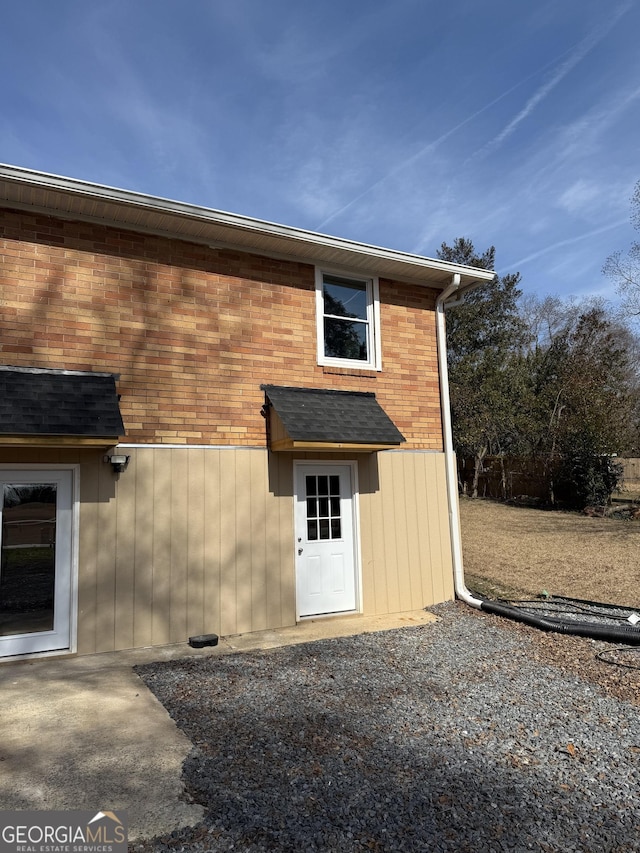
[{"left": 0, "top": 469, "right": 73, "bottom": 657}]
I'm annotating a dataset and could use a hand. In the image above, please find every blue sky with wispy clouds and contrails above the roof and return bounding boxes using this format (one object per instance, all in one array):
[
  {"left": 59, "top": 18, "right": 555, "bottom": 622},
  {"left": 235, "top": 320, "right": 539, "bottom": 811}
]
[{"left": 0, "top": 0, "right": 640, "bottom": 298}]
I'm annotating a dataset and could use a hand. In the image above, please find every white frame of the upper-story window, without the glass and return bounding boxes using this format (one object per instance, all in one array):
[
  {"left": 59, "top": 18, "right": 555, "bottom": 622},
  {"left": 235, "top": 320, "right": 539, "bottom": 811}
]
[{"left": 316, "top": 267, "right": 382, "bottom": 370}]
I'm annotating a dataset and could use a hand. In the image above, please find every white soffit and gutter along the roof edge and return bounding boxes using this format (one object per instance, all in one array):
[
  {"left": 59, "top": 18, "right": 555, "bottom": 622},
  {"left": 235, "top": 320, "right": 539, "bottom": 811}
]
[{"left": 0, "top": 164, "right": 494, "bottom": 288}]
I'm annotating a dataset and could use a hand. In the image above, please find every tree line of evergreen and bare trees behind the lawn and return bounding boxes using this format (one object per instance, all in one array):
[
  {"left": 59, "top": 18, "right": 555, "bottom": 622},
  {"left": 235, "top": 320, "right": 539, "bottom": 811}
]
[{"left": 438, "top": 218, "right": 640, "bottom": 508}]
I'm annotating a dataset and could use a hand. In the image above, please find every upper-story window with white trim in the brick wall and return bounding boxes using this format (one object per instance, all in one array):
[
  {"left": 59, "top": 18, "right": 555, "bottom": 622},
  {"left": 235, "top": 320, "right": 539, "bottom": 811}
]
[{"left": 316, "top": 270, "right": 380, "bottom": 370}]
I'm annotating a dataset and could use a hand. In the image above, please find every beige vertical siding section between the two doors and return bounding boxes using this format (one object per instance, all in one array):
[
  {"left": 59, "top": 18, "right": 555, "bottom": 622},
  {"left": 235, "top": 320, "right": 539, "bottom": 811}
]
[{"left": 78, "top": 447, "right": 295, "bottom": 653}]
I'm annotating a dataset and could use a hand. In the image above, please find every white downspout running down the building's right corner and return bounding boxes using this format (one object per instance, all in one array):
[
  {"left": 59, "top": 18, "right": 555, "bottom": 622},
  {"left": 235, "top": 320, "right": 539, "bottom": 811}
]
[{"left": 436, "top": 273, "right": 482, "bottom": 609}]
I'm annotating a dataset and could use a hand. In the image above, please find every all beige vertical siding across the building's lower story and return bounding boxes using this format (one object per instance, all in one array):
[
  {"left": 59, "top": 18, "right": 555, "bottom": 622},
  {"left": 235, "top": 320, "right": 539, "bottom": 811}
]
[{"left": 0, "top": 446, "right": 453, "bottom": 654}]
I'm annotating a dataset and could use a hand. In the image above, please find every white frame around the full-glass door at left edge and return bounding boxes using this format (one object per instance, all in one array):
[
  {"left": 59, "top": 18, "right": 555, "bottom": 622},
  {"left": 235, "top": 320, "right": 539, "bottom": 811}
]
[{"left": 0, "top": 462, "right": 80, "bottom": 661}]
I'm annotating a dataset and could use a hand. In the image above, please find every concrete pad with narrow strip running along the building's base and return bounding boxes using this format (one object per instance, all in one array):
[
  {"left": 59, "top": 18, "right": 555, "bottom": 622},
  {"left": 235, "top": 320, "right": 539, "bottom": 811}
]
[{"left": 0, "top": 610, "right": 436, "bottom": 841}]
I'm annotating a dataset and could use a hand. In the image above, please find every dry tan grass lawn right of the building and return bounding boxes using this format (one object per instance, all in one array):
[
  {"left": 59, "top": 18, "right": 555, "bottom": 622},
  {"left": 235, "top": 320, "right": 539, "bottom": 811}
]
[{"left": 460, "top": 498, "right": 640, "bottom": 608}]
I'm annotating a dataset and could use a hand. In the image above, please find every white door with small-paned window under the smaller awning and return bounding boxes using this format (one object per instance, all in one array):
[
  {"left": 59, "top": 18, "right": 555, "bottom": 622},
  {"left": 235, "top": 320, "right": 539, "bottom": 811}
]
[{"left": 295, "top": 463, "right": 357, "bottom": 616}]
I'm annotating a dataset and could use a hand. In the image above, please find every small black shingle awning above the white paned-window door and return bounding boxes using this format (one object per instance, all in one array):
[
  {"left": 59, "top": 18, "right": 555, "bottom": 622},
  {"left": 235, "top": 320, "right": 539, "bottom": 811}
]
[{"left": 260, "top": 385, "right": 405, "bottom": 451}]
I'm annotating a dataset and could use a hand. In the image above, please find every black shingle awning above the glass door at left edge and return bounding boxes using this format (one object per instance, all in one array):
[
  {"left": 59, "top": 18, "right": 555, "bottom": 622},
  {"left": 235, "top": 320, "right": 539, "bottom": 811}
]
[{"left": 0, "top": 366, "right": 124, "bottom": 447}]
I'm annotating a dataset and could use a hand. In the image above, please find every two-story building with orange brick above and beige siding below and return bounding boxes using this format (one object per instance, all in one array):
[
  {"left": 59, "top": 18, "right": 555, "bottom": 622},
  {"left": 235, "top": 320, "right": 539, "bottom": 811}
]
[{"left": 0, "top": 166, "right": 493, "bottom": 657}]
